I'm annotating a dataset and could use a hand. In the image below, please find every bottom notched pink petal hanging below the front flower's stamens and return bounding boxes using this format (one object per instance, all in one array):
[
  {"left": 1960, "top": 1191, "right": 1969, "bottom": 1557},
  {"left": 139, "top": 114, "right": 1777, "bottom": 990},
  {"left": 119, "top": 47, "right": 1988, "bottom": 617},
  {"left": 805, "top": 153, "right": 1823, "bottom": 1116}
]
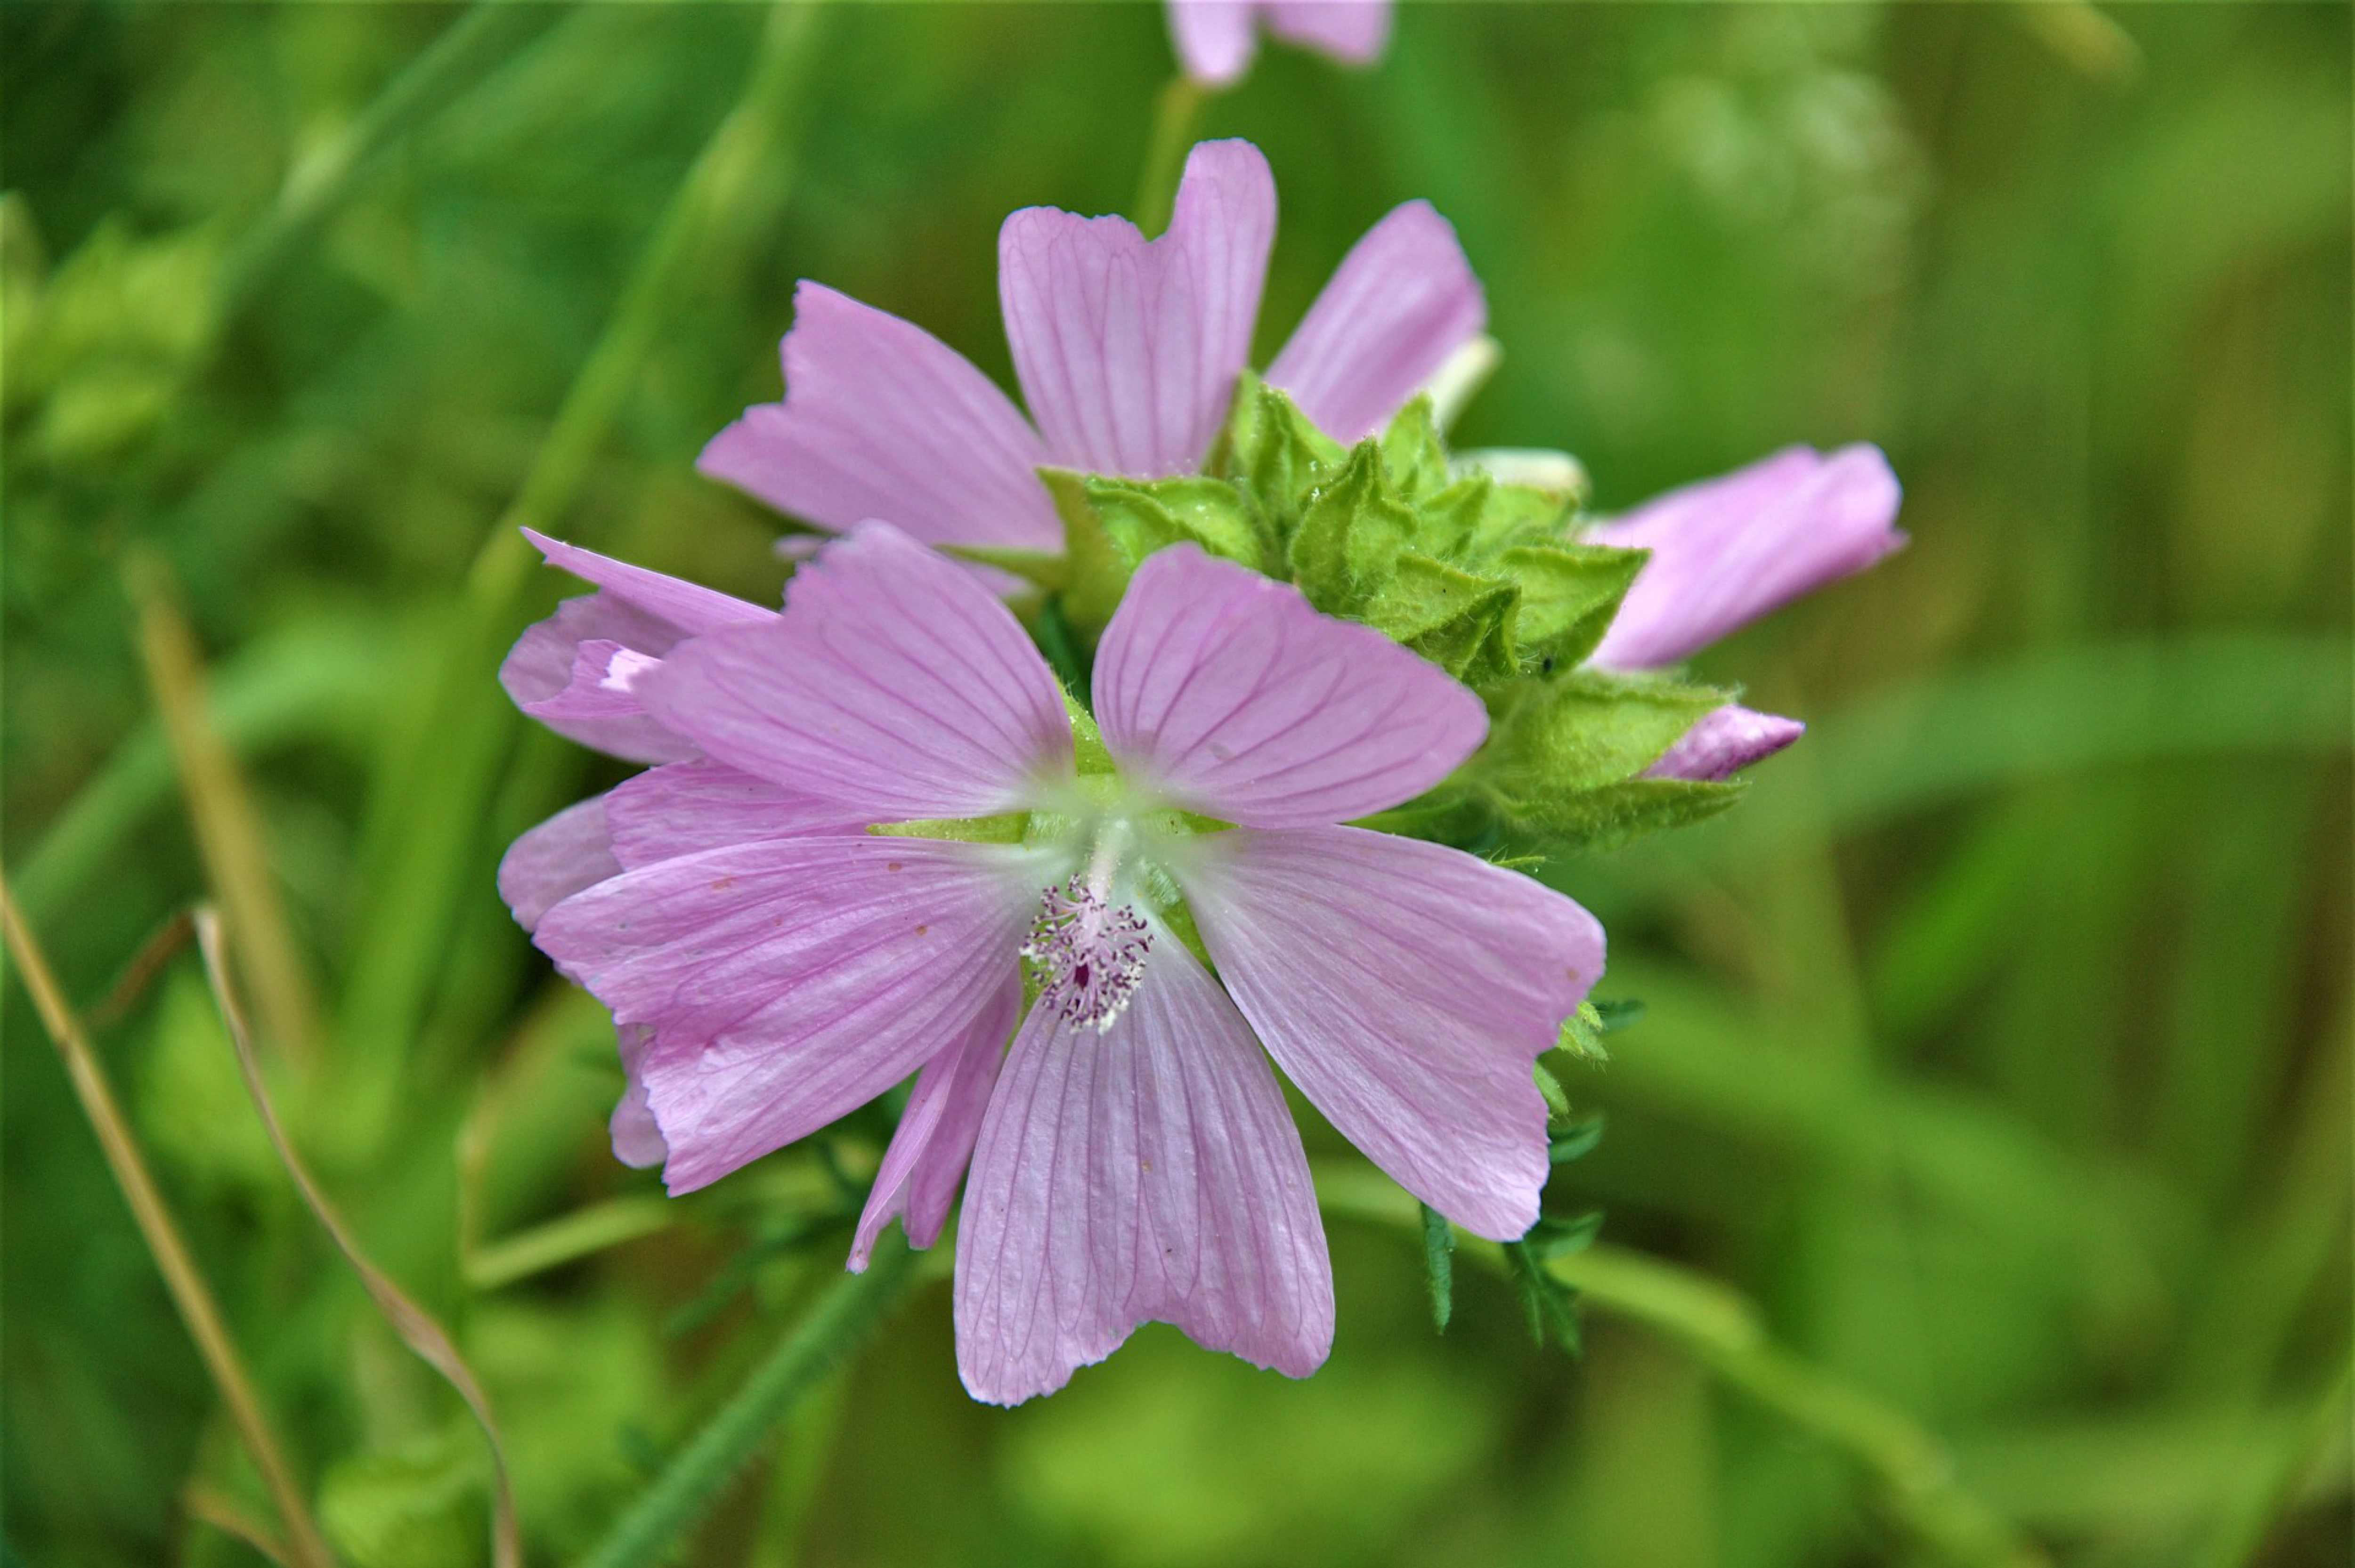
[{"left": 956, "top": 935, "right": 1328, "bottom": 1406}]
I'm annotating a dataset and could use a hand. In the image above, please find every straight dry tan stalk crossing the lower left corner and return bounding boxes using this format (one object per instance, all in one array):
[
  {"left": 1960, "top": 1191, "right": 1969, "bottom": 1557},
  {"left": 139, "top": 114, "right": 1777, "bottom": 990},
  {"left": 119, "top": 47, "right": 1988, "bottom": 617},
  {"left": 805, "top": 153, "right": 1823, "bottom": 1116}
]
[{"left": 0, "top": 881, "right": 334, "bottom": 1568}]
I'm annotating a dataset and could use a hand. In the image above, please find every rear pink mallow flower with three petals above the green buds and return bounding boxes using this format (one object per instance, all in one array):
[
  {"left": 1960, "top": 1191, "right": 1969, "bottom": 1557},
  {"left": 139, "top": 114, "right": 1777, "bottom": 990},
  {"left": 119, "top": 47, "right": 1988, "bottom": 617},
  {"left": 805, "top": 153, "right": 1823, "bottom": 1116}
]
[{"left": 697, "top": 141, "right": 1486, "bottom": 553}]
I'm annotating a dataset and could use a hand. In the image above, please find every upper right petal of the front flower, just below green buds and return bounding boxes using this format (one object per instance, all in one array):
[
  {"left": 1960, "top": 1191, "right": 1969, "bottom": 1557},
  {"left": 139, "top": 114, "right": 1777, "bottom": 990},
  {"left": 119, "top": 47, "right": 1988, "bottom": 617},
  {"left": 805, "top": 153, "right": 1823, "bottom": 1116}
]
[{"left": 1095, "top": 544, "right": 1488, "bottom": 826}]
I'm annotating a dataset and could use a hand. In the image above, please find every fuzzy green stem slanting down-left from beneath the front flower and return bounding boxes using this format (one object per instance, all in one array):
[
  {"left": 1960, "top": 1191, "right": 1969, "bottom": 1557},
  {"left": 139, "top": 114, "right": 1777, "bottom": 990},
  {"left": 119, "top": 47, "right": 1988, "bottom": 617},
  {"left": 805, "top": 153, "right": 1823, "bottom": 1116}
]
[{"left": 582, "top": 1231, "right": 918, "bottom": 1568}]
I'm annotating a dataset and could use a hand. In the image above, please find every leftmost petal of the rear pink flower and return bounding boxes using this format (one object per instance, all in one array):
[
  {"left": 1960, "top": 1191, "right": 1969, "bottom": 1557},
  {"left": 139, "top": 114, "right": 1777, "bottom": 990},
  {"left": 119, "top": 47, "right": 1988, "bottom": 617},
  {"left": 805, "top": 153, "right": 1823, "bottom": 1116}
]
[{"left": 695, "top": 283, "right": 1062, "bottom": 551}]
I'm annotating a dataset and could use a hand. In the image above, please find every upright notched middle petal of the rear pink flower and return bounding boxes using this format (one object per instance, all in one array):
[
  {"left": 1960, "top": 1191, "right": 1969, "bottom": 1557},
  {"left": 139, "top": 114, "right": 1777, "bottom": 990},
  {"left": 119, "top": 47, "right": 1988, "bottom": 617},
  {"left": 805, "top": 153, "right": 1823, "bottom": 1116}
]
[{"left": 999, "top": 141, "right": 1276, "bottom": 476}]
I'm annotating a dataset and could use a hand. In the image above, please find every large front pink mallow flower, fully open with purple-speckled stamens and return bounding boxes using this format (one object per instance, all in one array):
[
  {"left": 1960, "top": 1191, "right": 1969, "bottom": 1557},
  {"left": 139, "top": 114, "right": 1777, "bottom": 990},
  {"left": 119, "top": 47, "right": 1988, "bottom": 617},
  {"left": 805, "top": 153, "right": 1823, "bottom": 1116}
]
[{"left": 502, "top": 523, "right": 1604, "bottom": 1403}]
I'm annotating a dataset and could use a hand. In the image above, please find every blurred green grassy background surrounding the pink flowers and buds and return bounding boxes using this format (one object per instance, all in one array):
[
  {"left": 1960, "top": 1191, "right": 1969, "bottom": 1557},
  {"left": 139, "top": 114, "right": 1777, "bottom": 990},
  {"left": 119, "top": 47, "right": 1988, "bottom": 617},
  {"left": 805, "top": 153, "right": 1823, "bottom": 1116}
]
[{"left": 0, "top": 0, "right": 2355, "bottom": 1568}]
